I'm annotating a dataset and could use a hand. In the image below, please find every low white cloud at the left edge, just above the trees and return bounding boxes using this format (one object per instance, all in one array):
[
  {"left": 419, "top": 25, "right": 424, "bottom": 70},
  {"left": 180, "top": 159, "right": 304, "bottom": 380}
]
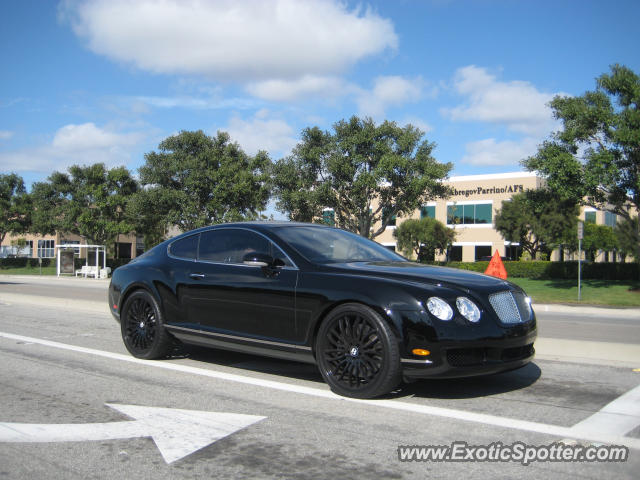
[{"left": 0, "top": 123, "right": 145, "bottom": 174}]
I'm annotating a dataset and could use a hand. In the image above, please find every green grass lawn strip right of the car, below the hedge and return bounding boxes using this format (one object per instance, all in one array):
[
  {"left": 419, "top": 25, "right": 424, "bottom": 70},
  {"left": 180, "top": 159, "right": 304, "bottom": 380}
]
[{"left": 508, "top": 278, "right": 640, "bottom": 307}]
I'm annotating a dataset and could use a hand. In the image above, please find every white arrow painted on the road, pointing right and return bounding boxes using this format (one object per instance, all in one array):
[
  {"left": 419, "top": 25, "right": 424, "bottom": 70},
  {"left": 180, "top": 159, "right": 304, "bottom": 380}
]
[{"left": 0, "top": 403, "right": 267, "bottom": 463}]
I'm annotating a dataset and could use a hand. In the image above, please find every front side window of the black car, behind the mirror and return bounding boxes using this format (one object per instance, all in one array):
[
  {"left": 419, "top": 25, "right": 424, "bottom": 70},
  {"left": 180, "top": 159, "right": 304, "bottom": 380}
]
[{"left": 198, "top": 228, "right": 291, "bottom": 266}]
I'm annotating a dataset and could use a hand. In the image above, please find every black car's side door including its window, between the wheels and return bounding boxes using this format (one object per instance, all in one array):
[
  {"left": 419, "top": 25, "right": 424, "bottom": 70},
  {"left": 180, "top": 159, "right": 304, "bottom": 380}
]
[{"left": 188, "top": 228, "right": 298, "bottom": 342}]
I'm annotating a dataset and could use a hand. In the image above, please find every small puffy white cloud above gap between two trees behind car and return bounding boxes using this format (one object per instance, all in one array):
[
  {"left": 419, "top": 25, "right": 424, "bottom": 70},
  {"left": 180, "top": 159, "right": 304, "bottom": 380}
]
[{"left": 222, "top": 110, "right": 297, "bottom": 158}]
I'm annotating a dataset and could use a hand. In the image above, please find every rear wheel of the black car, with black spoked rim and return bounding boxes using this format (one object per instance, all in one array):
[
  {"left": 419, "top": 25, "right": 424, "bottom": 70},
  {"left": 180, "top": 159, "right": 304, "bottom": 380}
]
[{"left": 120, "top": 290, "right": 173, "bottom": 360}]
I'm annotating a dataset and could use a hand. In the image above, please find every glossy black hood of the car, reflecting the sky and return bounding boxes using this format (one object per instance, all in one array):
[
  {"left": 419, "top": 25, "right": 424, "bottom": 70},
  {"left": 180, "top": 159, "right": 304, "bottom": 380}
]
[{"left": 328, "top": 262, "right": 519, "bottom": 292}]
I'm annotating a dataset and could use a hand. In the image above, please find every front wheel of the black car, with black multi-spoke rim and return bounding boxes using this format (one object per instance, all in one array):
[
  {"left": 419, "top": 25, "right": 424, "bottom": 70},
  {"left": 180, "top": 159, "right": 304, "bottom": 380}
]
[{"left": 315, "top": 303, "right": 401, "bottom": 398}]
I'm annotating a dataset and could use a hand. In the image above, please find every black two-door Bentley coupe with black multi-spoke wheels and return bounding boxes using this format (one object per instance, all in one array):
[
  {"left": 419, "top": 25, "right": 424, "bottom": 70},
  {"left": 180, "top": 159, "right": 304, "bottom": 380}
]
[{"left": 109, "top": 222, "right": 536, "bottom": 398}]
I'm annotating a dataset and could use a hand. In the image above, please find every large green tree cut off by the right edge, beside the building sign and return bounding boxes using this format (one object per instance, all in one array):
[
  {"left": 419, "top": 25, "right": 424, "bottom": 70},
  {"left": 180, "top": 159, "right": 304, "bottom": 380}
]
[{"left": 523, "top": 65, "right": 640, "bottom": 261}]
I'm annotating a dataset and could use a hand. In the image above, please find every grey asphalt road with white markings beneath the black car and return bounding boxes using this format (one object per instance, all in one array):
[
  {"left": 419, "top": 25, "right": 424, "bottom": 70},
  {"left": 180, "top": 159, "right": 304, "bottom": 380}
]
[{"left": 0, "top": 277, "right": 640, "bottom": 480}]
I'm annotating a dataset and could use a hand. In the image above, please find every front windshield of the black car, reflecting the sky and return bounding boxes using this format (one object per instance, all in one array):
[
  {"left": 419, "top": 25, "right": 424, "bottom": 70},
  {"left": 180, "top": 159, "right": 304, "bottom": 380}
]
[{"left": 278, "top": 226, "right": 406, "bottom": 263}]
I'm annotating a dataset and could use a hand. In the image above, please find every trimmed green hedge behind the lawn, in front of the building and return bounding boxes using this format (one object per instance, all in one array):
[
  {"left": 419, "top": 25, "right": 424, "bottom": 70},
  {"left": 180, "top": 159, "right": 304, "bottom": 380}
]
[{"left": 422, "top": 261, "right": 640, "bottom": 280}]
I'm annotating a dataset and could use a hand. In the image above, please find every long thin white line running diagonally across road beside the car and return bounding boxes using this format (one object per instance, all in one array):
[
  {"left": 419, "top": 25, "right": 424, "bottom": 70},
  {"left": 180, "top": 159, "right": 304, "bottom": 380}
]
[{"left": 0, "top": 332, "right": 640, "bottom": 450}]
